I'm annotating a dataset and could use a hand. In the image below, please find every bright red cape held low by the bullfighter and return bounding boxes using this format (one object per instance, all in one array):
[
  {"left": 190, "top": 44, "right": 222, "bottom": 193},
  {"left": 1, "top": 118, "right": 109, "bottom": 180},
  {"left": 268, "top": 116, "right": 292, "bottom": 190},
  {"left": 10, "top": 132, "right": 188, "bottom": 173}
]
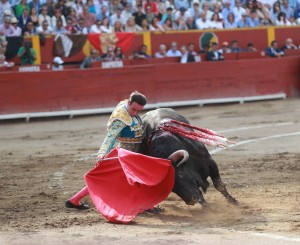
[{"left": 85, "top": 148, "right": 174, "bottom": 223}]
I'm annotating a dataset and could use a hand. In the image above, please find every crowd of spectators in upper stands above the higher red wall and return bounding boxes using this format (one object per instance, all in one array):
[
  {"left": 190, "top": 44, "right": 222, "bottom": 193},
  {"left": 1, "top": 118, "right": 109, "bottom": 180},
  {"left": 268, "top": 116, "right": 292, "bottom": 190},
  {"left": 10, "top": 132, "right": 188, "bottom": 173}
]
[{"left": 0, "top": 0, "right": 300, "bottom": 39}]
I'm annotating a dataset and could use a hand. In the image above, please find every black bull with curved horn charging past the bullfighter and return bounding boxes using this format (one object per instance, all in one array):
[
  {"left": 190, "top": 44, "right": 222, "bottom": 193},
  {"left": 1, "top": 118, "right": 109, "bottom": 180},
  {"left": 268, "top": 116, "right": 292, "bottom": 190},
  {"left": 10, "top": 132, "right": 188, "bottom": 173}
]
[{"left": 141, "top": 108, "right": 237, "bottom": 205}]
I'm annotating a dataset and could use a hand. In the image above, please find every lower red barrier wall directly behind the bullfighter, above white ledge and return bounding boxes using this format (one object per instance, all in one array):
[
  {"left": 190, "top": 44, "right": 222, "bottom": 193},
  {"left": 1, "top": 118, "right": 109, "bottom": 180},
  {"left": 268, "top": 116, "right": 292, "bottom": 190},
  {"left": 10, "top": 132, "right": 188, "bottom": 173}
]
[{"left": 0, "top": 56, "right": 300, "bottom": 115}]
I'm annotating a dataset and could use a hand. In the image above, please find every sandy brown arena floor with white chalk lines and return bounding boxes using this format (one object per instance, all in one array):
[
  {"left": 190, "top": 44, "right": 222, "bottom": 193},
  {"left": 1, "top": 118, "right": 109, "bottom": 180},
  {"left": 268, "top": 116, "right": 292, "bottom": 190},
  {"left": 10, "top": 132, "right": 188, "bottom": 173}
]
[{"left": 0, "top": 99, "right": 300, "bottom": 245}]
